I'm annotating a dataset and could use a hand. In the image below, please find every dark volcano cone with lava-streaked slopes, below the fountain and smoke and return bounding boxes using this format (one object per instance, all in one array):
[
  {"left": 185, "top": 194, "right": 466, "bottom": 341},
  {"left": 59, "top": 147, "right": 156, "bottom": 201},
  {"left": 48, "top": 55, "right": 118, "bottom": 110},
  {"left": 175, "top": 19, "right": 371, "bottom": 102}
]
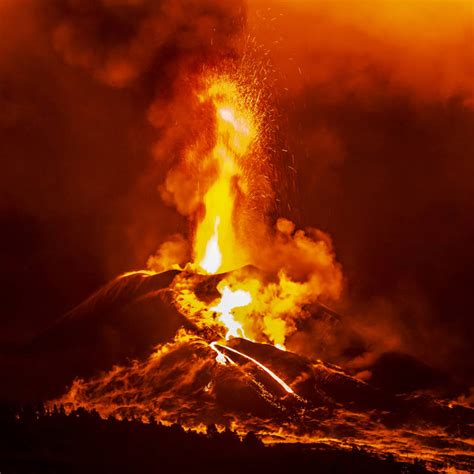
[{"left": 12, "top": 269, "right": 474, "bottom": 469}]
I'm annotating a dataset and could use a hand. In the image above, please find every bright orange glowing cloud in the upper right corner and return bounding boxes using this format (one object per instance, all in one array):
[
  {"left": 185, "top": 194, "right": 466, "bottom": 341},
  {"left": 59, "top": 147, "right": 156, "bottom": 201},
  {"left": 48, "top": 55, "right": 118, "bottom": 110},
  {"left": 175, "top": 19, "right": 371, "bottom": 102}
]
[{"left": 249, "top": 0, "right": 474, "bottom": 102}]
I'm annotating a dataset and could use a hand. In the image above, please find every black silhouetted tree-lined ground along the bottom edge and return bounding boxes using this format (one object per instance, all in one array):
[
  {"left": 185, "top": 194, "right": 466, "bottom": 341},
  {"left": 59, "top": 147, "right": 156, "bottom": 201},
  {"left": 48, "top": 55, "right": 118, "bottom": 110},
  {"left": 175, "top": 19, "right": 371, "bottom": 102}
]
[{"left": 0, "top": 406, "right": 429, "bottom": 474}]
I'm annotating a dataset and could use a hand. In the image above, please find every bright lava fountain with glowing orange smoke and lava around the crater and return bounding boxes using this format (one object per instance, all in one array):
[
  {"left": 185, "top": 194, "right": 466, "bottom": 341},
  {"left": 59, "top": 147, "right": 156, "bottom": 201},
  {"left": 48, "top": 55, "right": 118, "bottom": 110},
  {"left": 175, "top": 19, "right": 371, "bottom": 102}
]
[{"left": 51, "top": 68, "right": 342, "bottom": 411}]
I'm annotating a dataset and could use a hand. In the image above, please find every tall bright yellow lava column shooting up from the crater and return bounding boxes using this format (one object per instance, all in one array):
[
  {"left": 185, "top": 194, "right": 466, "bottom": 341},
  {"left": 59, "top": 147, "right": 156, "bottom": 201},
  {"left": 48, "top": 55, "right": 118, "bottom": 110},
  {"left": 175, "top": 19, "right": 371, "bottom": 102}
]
[{"left": 194, "top": 80, "right": 256, "bottom": 274}]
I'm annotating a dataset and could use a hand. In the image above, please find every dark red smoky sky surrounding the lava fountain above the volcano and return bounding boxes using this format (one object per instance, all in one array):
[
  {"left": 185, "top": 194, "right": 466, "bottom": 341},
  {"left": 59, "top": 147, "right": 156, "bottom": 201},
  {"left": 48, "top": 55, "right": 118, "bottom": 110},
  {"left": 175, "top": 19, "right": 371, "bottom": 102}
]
[{"left": 0, "top": 0, "right": 474, "bottom": 384}]
